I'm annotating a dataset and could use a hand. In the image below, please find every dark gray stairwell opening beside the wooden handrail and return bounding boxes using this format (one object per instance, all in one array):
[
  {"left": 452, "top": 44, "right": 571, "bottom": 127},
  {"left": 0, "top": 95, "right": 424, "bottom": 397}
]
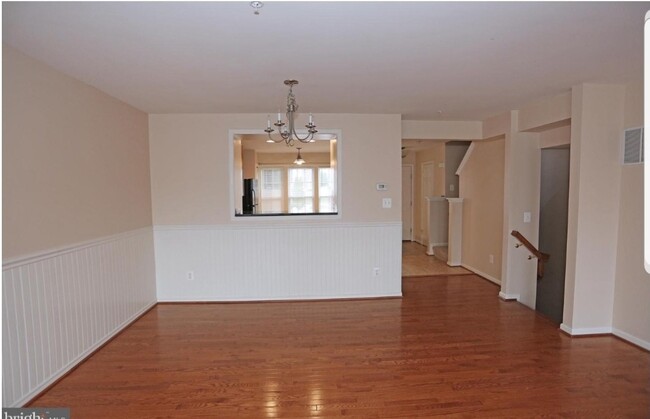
[{"left": 535, "top": 147, "right": 570, "bottom": 324}]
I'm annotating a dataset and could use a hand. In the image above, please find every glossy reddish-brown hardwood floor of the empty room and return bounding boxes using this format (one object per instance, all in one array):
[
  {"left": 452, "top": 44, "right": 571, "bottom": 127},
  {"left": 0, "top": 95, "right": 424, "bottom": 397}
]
[{"left": 33, "top": 275, "right": 650, "bottom": 419}]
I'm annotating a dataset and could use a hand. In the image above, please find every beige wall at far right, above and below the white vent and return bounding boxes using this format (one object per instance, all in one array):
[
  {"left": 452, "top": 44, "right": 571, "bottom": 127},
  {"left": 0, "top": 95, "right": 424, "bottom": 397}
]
[{"left": 613, "top": 82, "right": 650, "bottom": 349}]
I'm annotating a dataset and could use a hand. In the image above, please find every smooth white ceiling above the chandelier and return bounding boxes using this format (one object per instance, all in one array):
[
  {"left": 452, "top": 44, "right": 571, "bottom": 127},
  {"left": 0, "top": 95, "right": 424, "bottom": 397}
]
[{"left": 2, "top": 2, "right": 650, "bottom": 122}]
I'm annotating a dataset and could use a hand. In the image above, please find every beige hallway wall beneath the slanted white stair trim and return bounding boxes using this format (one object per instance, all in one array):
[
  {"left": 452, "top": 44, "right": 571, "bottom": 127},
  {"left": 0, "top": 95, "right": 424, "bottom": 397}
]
[{"left": 460, "top": 139, "right": 505, "bottom": 280}]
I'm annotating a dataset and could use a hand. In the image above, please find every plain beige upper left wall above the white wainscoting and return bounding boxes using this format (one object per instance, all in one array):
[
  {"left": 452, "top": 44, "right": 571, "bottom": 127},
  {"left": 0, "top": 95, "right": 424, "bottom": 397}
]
[{"left": 2, "top": 45, "right": 151, "bottom": 260}]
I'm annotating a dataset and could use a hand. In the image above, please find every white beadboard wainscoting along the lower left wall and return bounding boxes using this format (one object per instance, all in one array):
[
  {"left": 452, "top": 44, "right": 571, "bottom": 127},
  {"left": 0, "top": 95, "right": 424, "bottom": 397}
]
[{"left": 2, "top": 227, "right": 156, "bottom": 407}]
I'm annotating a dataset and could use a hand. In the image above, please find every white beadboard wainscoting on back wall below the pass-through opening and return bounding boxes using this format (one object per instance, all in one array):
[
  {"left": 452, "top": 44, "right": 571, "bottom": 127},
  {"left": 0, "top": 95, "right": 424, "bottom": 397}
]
[{"left": 154, "top": 223, "right": 402, "bottom": 302}]
